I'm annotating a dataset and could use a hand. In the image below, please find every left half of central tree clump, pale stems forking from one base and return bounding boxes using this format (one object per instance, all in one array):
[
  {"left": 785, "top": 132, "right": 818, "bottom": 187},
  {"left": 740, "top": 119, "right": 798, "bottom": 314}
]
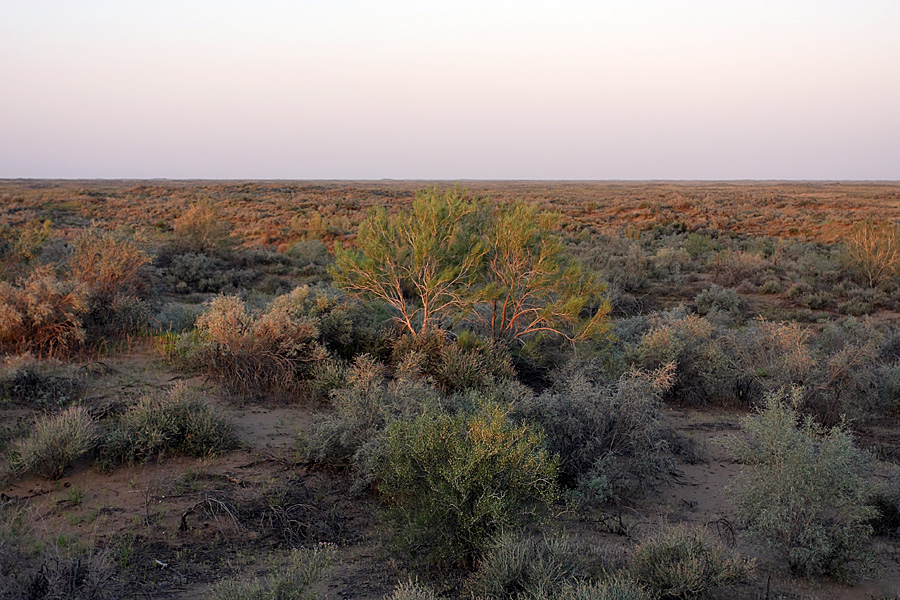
[{"left": 330, "top": 188, "right": 484, "bottom": 335}]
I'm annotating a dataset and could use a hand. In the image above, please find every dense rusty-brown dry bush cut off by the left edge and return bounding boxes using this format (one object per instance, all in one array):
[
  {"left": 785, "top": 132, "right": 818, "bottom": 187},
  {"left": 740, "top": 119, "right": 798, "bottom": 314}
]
[{"left": 0, "top": 267, "right": 88, "bottom": 358}]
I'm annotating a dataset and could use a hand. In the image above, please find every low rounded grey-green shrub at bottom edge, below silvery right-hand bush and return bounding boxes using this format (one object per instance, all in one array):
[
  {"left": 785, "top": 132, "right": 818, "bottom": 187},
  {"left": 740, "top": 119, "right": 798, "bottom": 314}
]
[{"left": 631, "top": 526, "right": 754, "bottom": 600}]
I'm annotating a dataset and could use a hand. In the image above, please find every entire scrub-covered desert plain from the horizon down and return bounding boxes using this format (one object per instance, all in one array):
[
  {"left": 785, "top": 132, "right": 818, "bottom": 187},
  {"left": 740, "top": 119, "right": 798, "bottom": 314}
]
[{"left": 0, "top": 181, "right": 900, "bottom": 600}]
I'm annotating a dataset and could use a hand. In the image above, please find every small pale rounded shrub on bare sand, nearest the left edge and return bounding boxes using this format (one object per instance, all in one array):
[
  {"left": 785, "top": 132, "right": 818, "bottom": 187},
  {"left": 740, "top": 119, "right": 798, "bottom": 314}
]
[{"left": 12, "top": 406, "right": 97, "bottom": 479}]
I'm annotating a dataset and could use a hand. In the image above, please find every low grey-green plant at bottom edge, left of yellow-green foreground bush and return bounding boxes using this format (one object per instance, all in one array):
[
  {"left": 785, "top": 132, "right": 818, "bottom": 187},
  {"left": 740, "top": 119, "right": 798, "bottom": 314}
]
[{"left": 213, "top": 544, "right": 334, "bottom": 600}]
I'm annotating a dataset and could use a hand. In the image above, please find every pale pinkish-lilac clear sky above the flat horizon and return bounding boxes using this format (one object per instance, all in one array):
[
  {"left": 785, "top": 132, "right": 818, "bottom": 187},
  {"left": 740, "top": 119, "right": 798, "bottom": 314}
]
[{"left": 0, "top": 0, "right": 900, "bottom": 180}]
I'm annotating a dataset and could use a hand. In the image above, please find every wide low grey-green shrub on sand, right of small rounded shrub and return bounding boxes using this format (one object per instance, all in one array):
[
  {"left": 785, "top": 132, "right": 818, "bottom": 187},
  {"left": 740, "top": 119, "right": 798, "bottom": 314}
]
[{"left": 102, "top": 383, "right": 238, "bottom": 467}]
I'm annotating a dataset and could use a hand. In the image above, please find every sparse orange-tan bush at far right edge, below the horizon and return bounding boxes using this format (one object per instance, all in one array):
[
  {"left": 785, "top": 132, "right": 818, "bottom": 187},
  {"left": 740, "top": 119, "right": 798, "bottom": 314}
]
[{"left": 844, "top": 220, "right": 900, "bottom": 287}]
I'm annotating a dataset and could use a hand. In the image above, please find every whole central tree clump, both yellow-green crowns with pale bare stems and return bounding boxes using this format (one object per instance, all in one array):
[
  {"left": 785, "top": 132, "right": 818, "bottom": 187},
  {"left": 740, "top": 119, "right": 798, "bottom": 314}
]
[{"left": 331, "top": 188, "right": 610, "bottom": 344}]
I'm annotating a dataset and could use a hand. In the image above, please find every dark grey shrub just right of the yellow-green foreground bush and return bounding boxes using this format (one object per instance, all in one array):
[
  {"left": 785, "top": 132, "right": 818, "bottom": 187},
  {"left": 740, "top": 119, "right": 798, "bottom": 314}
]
[{"left": 515, "top": 368, "right": 672, "bottom": 504}]
